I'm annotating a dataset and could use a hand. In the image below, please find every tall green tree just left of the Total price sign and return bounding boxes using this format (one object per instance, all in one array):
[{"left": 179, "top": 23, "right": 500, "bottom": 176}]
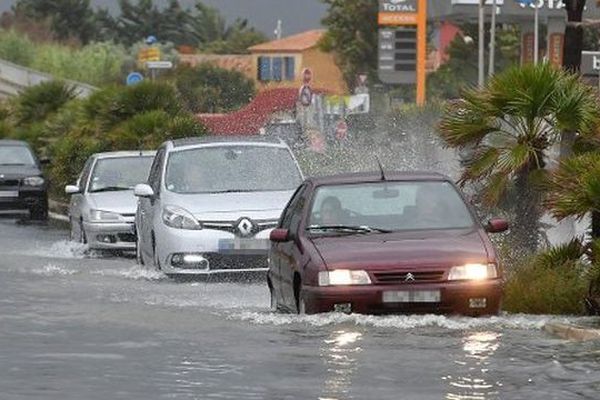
[{"left": 322, "top": 0, "right": 378, "bottom": 87}]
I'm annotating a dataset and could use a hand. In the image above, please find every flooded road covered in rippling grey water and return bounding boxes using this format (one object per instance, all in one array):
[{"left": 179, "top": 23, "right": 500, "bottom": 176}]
[{"left": 0, "top": 219, "right": 600, "bottom": 400}]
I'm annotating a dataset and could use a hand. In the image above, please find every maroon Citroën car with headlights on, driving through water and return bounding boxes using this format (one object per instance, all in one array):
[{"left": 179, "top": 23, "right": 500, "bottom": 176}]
[{"left": 268, "top": 172, "right": 508, "bottom": 316}]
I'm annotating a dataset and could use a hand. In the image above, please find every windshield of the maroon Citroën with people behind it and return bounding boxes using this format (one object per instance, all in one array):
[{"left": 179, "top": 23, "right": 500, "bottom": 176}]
[{"left": 308, "top": 181, "right": 474, "bottom": 231}]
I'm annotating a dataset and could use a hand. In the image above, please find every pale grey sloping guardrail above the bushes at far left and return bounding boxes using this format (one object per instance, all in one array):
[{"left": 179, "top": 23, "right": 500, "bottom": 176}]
[{"left": 0, "top": 60, "right": 97, "bottom": 98}]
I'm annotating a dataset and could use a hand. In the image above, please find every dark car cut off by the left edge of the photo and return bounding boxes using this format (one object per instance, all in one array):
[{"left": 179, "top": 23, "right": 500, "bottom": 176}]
[{"left": 0, "top": 140, "right": 48, "bottom": 220}]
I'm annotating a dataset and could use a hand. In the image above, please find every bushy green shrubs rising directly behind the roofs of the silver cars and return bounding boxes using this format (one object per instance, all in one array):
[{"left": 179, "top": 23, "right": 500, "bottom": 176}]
[{"left": 45, "top": 82, "right": 206, "bottom": 198}]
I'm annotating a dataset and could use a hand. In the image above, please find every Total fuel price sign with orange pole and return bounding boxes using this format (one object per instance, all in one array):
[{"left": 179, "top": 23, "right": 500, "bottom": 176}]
[{"left": 378, "top": 0, "right": 427, "bottom": 104}]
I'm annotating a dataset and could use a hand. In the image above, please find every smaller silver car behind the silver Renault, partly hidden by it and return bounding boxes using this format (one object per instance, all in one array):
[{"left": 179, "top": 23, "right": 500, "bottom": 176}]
[{"left": 65, "top": 151, "right": 155, "bottom": 250}]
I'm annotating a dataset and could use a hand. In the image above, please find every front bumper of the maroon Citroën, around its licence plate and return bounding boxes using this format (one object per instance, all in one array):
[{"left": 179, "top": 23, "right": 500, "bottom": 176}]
[{"left": 302, "top": 279, "right": 502, "bottom": 316}]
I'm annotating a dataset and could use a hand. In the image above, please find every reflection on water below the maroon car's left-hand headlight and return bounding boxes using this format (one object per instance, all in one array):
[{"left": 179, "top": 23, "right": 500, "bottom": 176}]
[{"left": 319, "top": 330, "right": 362, "bottom": 400}]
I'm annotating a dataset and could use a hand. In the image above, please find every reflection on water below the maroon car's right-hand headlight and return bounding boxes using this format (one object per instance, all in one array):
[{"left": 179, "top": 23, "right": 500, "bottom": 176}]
[{"left": 442, "top": 332, "right": 502, "bottom": 400}]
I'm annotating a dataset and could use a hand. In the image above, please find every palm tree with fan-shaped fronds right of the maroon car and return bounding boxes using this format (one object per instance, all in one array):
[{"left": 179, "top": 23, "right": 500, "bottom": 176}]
[{"left": 439, "top": 64, "right": 600, "bottom": 252}]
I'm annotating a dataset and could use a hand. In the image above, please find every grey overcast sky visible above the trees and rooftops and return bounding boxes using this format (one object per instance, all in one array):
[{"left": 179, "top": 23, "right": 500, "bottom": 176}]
[{"left": 0, "top": 0, "right": 326, "bottom": 37}]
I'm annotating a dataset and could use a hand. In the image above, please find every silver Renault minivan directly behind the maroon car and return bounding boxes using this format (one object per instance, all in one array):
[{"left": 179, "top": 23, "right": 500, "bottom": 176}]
[{"left": 135, "top": 137, "right": 303, "bottom": 276}]
